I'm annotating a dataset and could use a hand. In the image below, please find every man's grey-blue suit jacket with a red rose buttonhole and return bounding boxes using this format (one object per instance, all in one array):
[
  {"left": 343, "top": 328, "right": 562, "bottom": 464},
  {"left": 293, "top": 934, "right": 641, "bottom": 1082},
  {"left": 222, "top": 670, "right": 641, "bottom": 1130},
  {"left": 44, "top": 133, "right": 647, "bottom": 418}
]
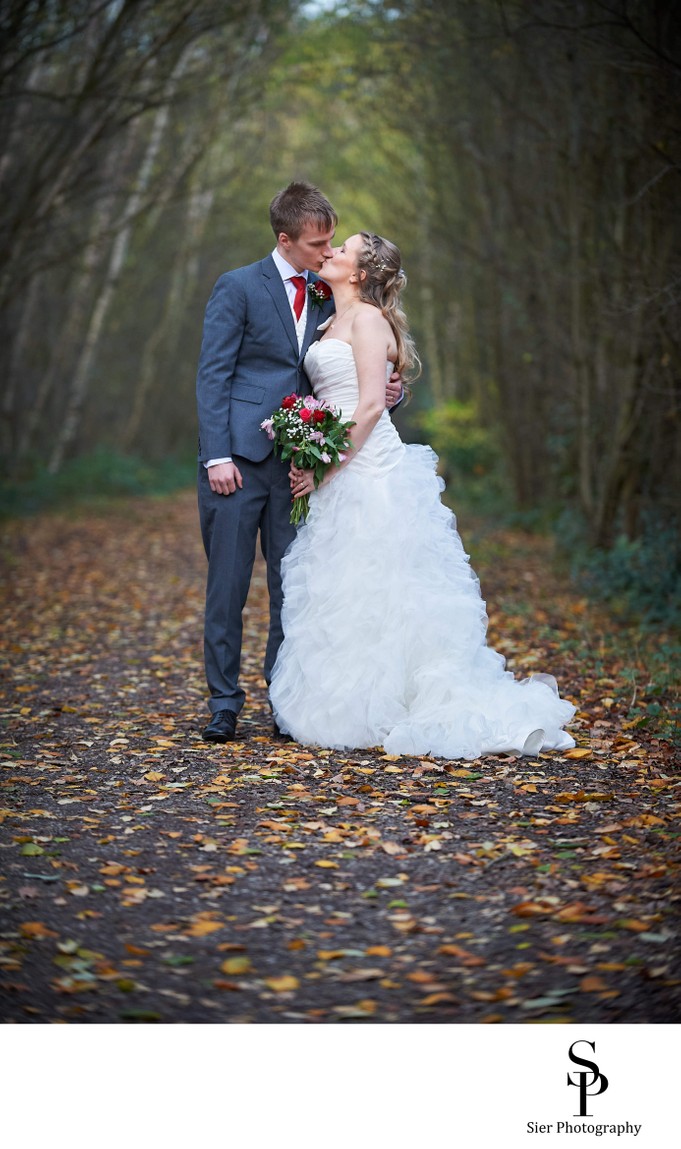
[{"left": 196, "top": 255, "right": 333, "bottom": 463}]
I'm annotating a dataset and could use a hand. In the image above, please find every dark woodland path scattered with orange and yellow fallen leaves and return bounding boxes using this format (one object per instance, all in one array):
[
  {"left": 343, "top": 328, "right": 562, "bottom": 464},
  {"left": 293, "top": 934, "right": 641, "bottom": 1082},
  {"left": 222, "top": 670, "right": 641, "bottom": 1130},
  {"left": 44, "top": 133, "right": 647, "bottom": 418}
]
[{"left": 0, "top": 492, "right": 681, "bottom": 1024}]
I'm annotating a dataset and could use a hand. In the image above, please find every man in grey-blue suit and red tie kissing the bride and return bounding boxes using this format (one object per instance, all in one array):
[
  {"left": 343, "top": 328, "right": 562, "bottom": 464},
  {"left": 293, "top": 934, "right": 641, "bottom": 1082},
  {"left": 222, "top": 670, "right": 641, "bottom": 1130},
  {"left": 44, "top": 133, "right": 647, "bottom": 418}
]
[{"left": 196, "top": 176, "right": 401, "bottom": 742}]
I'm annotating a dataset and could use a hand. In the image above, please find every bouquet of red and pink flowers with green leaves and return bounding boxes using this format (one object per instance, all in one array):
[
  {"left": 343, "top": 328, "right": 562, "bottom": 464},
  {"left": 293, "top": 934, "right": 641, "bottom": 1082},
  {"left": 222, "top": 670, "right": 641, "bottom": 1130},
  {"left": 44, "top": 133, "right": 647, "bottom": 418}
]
[{"left": 261, "top": 395, "right": 355, "bottom": 525}]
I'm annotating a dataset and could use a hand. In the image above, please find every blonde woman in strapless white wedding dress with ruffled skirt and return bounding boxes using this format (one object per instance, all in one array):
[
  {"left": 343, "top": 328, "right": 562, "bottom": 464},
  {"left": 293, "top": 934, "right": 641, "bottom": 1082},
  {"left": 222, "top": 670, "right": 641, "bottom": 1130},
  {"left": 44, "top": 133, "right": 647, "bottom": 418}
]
[{"left": 270, "top": 232, "right": 574, "bottom": 758}]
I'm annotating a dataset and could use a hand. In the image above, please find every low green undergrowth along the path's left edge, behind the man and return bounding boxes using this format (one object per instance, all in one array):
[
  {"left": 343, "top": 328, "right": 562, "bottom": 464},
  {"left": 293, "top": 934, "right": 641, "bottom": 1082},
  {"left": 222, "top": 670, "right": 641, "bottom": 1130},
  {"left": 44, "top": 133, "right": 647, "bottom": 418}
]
[{"left": 0, "top": 448, "right": 196, "bottom": 518}]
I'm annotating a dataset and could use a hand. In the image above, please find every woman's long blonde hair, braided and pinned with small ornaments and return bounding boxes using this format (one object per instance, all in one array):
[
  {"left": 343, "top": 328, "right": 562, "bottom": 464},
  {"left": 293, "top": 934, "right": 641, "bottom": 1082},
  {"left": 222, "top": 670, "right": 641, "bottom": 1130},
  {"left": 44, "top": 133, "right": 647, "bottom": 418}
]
[{"left": 357, "top": 231, "right": 421, "bottom": 380}]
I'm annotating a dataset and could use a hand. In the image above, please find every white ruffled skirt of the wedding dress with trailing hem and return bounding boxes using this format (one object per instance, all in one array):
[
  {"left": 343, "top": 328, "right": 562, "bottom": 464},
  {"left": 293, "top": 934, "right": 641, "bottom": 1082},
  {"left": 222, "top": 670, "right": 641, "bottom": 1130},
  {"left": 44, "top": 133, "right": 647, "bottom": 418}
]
[{"left": 270, "top": 445, "right": 574, "bottom": 758}]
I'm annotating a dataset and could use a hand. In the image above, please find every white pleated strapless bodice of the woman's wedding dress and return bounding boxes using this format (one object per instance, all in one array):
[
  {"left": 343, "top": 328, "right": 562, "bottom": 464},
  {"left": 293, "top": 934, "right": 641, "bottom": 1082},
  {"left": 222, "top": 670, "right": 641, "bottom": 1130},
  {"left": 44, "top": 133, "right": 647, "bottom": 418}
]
[{"left": 305, "top": 337, "right": 404, "bottom": 473}]
